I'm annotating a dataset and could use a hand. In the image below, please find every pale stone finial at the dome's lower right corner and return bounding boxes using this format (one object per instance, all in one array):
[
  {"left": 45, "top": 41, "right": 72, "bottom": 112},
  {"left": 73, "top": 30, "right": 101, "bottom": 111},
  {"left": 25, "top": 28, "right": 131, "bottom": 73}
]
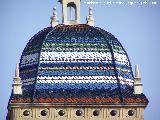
[{"left": 134, "top": 65, "right": 143, "bottom": 94}]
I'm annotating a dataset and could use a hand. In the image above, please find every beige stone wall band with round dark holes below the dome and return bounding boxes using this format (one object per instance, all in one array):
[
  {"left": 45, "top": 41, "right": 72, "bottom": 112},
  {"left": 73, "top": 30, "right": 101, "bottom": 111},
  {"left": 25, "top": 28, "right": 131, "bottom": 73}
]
[{"left": 10, "top": 106, "right": 144, "bottom": 120}]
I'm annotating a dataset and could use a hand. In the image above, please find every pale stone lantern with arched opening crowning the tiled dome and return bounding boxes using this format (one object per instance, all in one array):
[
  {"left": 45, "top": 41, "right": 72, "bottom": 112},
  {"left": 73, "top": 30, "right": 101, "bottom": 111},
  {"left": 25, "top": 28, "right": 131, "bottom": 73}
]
[{"left": 59, "top": 0, "right": 81, "bottom": 25}]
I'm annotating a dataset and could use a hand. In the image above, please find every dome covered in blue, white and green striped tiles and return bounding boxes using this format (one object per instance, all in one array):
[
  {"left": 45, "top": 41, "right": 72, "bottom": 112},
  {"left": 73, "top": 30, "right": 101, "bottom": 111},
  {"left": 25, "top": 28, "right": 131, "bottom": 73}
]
[{"left": 11, "top": 24, "right": 147, "bottom": 104}]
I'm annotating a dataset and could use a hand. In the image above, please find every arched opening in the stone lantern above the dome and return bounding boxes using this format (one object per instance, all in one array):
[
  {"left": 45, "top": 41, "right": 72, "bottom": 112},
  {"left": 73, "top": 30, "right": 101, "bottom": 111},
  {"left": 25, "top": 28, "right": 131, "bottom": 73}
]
[{"left": 67, "top": 2, "right": 77, "bottom": 20}]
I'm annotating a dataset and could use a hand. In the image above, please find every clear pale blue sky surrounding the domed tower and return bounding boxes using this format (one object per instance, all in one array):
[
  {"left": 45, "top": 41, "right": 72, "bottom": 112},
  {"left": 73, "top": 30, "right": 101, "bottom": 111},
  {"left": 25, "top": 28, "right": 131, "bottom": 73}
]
[{"left": 0, "top": 0, "right": 160, "bottom": 120}]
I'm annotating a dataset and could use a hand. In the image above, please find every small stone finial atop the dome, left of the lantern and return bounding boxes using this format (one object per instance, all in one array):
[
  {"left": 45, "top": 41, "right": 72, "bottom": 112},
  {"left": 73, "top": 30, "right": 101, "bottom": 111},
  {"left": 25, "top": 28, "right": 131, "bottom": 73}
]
[{"left": 51, "top": 7, "right": 59, "bottom": 27}]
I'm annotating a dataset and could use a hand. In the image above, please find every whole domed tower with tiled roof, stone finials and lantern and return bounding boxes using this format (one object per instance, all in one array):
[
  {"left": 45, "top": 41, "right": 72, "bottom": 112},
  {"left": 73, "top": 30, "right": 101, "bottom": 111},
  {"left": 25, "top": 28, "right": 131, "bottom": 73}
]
[{"left": 6, "top": 0, "right": 148, "bottom": 120}]
